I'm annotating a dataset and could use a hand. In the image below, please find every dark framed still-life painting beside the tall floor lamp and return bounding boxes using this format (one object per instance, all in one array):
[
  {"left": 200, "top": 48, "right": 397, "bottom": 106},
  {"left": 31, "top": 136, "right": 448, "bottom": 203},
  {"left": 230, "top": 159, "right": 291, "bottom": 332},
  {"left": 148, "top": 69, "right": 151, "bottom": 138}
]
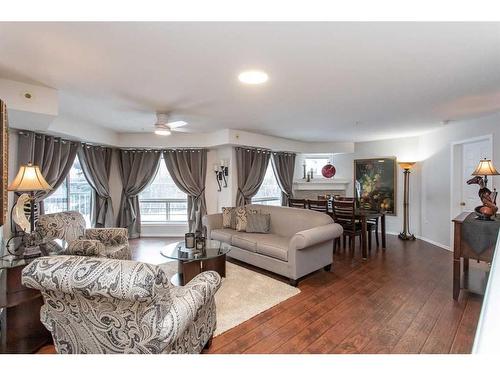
[{"left": 354, "top": 157, "right": 397, "bottom": 215}]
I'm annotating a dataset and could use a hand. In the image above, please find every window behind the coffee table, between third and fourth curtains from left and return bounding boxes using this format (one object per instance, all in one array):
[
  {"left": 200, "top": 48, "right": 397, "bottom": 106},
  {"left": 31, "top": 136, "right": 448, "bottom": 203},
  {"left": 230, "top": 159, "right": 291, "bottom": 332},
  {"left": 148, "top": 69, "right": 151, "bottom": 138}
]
[{"left": 139, "top": 158, "right": 187, "bottom": 223}]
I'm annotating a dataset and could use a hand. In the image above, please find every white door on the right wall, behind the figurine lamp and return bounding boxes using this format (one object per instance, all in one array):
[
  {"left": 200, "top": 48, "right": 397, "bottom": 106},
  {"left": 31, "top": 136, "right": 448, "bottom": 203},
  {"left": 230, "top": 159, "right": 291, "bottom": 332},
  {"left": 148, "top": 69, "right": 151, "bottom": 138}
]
[{"left": 461, "top": 139, "right": 492, "bottom": 211}]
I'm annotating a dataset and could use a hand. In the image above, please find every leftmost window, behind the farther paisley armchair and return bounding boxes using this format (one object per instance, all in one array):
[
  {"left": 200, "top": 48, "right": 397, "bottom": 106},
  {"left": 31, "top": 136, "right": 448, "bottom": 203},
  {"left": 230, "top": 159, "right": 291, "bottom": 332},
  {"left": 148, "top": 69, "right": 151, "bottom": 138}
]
[{"left": 43, "top": 157, "right": 93, "bottom": 227}]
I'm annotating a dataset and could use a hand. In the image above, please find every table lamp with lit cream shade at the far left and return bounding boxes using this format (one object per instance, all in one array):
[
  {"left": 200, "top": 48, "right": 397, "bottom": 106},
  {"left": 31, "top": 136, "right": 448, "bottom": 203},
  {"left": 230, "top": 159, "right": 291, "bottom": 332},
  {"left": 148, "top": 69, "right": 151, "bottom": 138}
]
[{"left": 7, "top": 163, "right": 52, "bottom": 233}]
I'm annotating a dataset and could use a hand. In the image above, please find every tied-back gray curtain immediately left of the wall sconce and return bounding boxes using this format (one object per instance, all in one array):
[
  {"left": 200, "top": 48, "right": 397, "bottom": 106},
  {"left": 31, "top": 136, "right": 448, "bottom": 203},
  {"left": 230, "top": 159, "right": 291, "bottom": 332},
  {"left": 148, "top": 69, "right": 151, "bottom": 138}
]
[{"left": 163, "top": 150, "right": 207, "bottom": 232}]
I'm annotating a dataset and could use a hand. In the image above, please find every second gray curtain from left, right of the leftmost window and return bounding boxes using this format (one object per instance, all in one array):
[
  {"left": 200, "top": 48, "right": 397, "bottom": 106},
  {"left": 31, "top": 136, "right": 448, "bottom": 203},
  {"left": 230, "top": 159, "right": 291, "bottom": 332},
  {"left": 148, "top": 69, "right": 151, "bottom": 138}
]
[{"left": 78, "top": 144, "right": 115, "bottom": 228}]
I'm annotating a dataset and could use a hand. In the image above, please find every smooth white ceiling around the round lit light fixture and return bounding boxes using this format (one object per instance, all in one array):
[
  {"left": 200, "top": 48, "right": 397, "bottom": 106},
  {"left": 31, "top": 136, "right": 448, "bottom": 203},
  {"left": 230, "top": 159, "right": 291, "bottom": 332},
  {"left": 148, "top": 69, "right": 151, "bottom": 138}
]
[{"left": 0, "top": 22, "right": 500, "bottom": 141}]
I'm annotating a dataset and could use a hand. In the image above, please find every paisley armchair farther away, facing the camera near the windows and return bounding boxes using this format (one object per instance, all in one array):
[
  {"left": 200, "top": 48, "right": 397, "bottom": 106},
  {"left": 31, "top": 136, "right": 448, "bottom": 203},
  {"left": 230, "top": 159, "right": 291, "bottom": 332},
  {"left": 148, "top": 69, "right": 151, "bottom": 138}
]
[{"left": 25, "top": 211, "right": 131, "bottom": 259}]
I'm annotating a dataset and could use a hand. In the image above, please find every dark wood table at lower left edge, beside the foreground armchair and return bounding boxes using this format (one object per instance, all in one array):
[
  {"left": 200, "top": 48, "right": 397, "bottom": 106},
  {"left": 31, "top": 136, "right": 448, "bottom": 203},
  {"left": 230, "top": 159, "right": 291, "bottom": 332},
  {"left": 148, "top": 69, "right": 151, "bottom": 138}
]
[{"left": 0, "top": 259, "right": 52, "bottom": 353}]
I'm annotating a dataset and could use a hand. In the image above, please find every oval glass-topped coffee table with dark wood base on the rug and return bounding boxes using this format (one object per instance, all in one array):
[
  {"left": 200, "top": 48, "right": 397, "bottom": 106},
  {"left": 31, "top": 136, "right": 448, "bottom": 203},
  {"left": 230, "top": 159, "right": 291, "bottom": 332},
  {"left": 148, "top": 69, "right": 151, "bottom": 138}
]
[{"left": 161, "top": 240, "right": 231, "bottom": 286}]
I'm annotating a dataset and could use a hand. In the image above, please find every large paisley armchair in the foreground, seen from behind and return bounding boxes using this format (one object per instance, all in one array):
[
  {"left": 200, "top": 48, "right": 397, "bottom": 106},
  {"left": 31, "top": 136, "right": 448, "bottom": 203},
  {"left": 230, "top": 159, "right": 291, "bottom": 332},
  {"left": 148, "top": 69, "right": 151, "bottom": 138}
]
[{"left": 22, "top": 256, "right": 221, "bottom": 354}]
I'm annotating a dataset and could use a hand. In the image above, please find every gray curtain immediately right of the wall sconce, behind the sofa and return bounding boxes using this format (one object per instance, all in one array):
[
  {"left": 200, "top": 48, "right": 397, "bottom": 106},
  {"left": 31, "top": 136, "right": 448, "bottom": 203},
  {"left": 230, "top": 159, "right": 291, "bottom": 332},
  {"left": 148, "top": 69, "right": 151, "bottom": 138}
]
[{"left": 235, "top": 147, "right": 271, "bottom": 206}]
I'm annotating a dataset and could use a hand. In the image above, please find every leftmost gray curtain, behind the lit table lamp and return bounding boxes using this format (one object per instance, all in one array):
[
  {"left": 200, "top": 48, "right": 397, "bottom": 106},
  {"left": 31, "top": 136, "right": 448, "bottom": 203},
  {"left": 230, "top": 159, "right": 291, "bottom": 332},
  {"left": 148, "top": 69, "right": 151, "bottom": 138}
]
[{"left": 18, "top": 131, "right": 80, "bottom": 214}]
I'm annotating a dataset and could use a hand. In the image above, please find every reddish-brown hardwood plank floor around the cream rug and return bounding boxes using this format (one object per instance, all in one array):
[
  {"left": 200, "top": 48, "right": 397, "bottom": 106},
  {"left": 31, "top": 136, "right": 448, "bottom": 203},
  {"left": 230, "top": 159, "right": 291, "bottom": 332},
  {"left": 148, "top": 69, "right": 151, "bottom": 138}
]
[{"left": 36, "top": 236, "right": 485, "bottom": 353}]
